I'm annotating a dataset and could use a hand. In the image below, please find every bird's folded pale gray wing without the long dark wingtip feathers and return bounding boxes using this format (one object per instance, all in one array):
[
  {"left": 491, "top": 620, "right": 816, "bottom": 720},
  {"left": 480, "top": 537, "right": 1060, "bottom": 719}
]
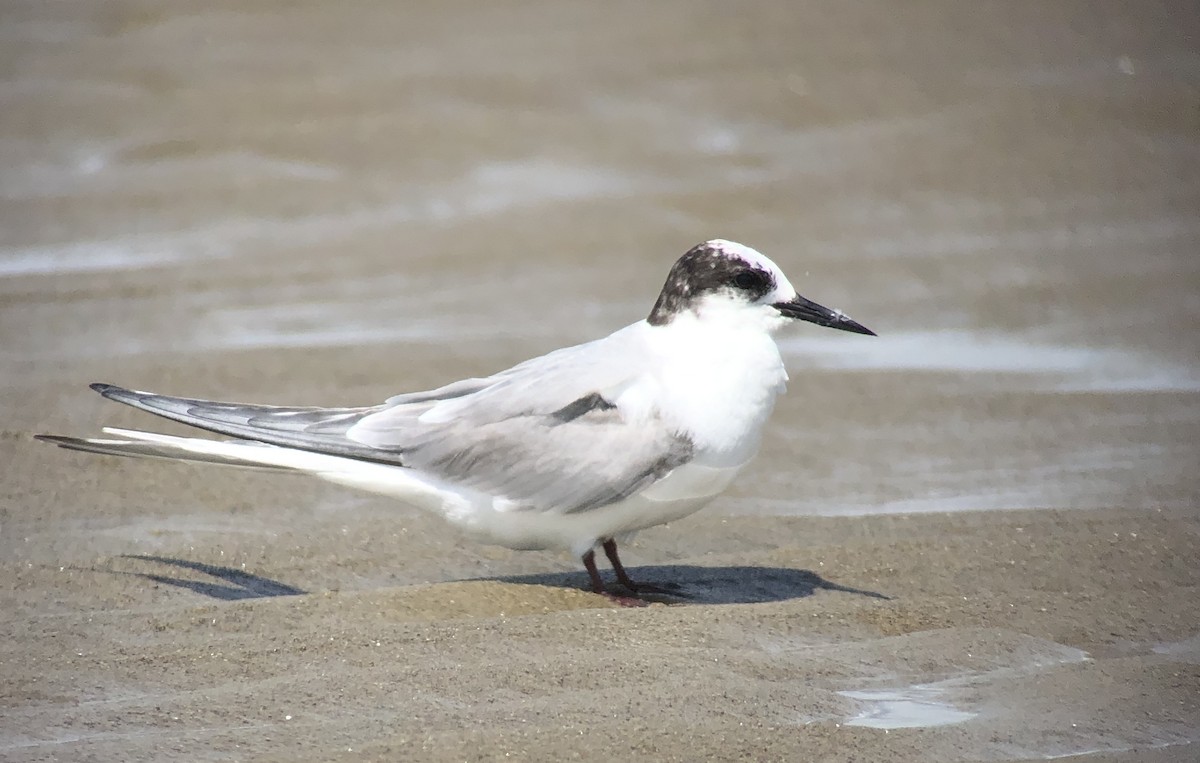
[{"left": 347, "top": 324, "right": 692, "bottom": 512}]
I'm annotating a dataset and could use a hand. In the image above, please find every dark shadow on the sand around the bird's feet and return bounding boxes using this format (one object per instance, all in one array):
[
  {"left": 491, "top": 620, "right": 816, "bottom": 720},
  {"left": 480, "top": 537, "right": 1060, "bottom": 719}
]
[{"left": 480, "top": 564, "right": 892, "bottom": 605}]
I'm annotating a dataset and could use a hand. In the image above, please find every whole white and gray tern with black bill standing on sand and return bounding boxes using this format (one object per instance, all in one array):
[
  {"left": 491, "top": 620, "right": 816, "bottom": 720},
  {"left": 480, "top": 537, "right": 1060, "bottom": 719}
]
[{"left": 37, "top": 239, "right": 875, "bottom": 606}]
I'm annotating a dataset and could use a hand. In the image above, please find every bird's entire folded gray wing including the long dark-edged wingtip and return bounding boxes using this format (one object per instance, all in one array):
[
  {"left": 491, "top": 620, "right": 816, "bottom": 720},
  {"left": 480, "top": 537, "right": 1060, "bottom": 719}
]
[{"left": 84, "top": 324, "right": 692, "bottom": 512}]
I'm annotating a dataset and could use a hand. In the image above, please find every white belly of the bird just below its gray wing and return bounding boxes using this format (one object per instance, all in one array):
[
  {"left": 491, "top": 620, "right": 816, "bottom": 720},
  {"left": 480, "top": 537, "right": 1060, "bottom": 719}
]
[{"left": 449, "top": 464, "right": 740, "bottom": 554}]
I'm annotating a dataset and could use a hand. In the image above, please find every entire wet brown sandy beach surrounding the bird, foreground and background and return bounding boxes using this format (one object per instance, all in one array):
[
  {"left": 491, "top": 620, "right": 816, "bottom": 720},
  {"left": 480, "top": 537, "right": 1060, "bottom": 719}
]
[{"left": 0, "top": 1, "right": 1200, "bottom": 763}]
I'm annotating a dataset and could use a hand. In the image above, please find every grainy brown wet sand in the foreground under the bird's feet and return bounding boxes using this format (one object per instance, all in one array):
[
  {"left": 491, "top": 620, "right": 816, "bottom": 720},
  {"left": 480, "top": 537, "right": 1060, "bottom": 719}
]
[{"left": 2, "top": 463, "right": 1200, "bottom": 761}]
